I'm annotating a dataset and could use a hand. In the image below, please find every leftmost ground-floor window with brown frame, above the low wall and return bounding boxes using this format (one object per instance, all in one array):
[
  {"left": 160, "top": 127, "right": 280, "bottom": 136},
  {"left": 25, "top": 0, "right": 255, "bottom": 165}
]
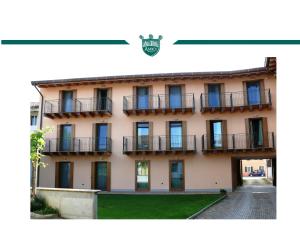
[{"left": 58, "top": 162, "right": 72, "bottom": 188}]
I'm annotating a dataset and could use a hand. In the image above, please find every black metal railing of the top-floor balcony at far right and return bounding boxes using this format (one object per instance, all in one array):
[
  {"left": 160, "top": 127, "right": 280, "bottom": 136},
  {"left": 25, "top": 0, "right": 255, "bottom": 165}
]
[{"left": 200, "top": 89, "right": 272, "bottom": 109}]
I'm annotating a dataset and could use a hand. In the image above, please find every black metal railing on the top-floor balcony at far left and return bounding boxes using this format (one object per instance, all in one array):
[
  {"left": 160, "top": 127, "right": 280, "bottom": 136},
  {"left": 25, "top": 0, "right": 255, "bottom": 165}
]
[{"left": 44, "top": 98, "right": 112, "bottom": 113}]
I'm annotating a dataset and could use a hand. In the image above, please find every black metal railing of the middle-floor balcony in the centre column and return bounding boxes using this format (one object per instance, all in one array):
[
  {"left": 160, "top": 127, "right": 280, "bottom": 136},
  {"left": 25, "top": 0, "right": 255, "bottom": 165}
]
[{"left": 123, "top": 135, "right": 196, "bottom": 154}]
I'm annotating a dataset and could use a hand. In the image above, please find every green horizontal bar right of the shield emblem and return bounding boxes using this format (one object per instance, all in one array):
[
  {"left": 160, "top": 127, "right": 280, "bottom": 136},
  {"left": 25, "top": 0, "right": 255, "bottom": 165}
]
[{"left": 174, "top": 40, "right": 300, "bottom": 45}]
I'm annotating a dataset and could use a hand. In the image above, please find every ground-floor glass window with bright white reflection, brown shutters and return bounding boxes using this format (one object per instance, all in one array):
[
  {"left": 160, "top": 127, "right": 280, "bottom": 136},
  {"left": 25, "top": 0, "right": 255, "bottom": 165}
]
[{"left": 136, "top": 161, "right": 150, "bottom": 191}]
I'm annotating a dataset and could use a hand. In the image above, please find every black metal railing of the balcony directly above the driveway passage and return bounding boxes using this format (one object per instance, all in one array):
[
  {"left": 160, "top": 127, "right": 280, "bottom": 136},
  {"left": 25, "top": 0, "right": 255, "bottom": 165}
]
[{"left": 201, "top": 132, "right": 276, "bottom": 152}]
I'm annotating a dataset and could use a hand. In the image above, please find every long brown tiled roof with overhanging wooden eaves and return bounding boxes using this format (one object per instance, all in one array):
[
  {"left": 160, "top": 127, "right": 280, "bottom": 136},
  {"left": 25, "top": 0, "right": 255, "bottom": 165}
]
[{"left": 31, "top": 57, "right": 276, "bottom": 88}]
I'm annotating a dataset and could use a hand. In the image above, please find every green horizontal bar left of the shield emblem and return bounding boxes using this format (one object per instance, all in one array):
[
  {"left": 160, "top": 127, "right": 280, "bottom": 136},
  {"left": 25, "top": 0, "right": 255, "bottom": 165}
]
[{"left": 1, "top": 40, "right": 129, "bottom": 45}]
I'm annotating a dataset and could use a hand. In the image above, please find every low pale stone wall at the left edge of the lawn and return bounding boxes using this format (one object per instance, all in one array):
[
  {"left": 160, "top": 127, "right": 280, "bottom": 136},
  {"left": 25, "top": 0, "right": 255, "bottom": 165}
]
[{"left": 37, "top": 188, "right": 99, "bottom": 219}]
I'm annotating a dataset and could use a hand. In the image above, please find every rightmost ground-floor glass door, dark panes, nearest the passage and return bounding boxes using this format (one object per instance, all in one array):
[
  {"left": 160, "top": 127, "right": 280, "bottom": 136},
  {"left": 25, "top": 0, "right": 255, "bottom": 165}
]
[{"left": 169, "top": 160, "right": 184, "bottom": 191}]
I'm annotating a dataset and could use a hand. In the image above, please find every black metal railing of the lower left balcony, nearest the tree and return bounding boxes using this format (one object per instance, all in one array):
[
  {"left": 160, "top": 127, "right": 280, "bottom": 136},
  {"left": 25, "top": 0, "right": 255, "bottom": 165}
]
[{"left": 43, "top": 137, "right": 112, "bottom": 155}]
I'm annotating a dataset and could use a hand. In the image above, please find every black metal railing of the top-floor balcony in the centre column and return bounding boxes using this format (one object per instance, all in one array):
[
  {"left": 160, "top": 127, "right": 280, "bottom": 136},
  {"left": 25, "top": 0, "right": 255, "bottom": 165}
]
[{"left": 123, "top": 93, "right": 195, "bottom": 110}]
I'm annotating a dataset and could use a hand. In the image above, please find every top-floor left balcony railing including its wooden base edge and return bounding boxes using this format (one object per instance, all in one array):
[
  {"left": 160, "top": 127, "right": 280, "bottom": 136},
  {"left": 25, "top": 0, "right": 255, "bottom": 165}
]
[{"left": 44, "top": 98, "right": 112, "bottom": 118}]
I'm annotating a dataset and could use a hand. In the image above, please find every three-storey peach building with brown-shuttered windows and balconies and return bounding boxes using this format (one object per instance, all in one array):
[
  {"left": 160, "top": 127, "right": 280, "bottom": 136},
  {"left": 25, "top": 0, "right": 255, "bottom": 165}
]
[{"left": 32, "top": 57, "right": 276, "bottom": 192}]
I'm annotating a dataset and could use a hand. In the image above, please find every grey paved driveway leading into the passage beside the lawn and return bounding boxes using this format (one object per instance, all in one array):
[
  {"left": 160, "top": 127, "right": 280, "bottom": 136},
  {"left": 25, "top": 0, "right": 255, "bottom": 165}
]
[{"left": 197, "top": 185, "right": 276, "bottom": 219}]
